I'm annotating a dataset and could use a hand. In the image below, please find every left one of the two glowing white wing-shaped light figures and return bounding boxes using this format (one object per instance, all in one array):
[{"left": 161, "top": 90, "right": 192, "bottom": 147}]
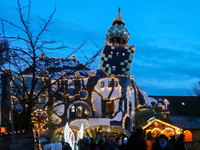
[{"left": 64, "top": 122, "right": 75, "bottom": 150}]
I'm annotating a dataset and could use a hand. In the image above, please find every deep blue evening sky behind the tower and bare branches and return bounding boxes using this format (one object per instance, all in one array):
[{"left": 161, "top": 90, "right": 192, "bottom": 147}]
[{"left": 0, "top": 0, "right": 200, "bottom": 96}]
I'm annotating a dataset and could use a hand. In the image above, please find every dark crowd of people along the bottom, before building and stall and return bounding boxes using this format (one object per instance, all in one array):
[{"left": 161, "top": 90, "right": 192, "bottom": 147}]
[{"left": 63, "top": 126, "right": 186, "bottom": 150}]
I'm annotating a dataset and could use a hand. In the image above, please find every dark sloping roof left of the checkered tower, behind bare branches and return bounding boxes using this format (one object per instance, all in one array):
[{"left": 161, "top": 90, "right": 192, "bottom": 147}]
[{"left": 22, "top": 57, "right": 91, "bottom": 79}]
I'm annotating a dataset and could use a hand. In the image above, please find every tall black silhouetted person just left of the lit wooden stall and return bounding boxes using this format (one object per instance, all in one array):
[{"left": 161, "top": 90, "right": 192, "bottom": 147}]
[{"left": 127, "top": 126, "right": 147, "bottom": 150}]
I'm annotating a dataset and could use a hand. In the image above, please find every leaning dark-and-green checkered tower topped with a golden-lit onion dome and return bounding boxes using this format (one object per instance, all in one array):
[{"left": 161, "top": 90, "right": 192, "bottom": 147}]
[{"left": 99, "top": 8, "right": 135, "bottom": 77}]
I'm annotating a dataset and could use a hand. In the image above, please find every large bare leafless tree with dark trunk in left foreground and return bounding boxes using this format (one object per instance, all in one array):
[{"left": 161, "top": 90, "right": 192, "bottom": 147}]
[{"left": 1, "top": 0, "right": 101, "bottom": 132}]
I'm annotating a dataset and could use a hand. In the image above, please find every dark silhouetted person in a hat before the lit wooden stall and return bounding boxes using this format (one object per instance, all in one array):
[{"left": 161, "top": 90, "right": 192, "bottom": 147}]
[{"left": 152, "top": 134, "right": 173, "bottom": 150}]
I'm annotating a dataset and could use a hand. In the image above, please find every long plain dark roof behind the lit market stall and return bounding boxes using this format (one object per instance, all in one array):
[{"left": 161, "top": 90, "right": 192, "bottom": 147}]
[{"left": 149, "top": 96, "right": 200, "bottom": 117}]
